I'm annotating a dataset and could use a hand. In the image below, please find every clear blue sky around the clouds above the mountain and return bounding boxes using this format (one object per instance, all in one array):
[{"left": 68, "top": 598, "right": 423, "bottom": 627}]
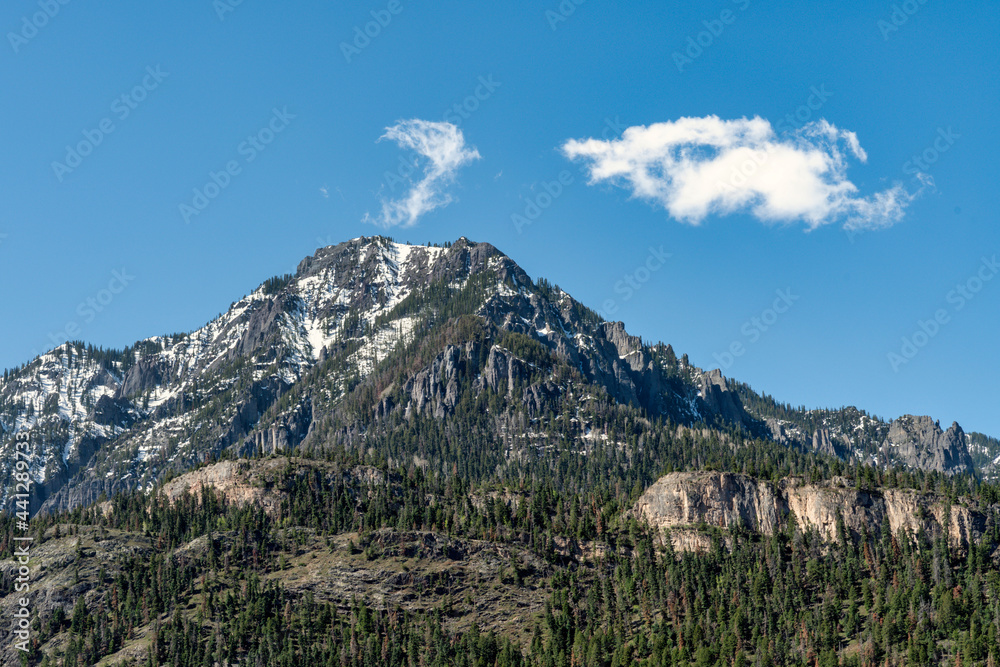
[{"left": 0, "top": 0, "right": 1000, "bottom": 435}]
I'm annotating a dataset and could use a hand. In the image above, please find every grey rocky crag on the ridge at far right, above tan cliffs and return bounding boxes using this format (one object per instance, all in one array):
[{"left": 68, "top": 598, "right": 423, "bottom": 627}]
[{"left": 882, "top": 415, "right": 974, "bottom": 475}]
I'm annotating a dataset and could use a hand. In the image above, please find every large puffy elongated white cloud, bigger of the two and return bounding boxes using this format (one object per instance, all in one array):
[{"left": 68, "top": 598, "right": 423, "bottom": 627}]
[{"left": 562, "top": 116, "right": 913, "bottom": 229}]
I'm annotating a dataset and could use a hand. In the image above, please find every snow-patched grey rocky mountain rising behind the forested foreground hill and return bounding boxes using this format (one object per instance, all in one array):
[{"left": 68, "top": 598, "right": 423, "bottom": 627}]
[{"left": 0, "top": 237, "right": 988, "bottom": 510}]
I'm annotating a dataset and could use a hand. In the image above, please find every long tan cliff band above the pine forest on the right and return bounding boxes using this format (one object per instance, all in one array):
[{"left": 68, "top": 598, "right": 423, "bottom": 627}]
[{"left": 634, "top": 472, "right": 988, "bottom": 550}]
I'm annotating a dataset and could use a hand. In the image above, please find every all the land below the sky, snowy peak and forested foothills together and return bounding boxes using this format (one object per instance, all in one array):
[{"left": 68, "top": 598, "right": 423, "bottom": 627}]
[{"left": 0, "top": 237, "right": 1000, "bottom": 666}]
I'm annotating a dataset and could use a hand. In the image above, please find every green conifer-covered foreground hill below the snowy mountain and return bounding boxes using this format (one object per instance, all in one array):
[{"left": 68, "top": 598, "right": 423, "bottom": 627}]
[{"left": 0, "top": 456, "right": 1000, "bottom": 666}]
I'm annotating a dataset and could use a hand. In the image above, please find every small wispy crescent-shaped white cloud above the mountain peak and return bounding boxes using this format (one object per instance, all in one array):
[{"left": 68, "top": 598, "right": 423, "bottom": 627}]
[{"left": 364, "top": 118, "right": 480, "bottom": 227}]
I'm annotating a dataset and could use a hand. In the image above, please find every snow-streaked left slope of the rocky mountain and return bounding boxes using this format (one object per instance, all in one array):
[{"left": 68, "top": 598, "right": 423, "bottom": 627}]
[{"left": 0, "top": 238, "right": 458, "bottom": 504}]
